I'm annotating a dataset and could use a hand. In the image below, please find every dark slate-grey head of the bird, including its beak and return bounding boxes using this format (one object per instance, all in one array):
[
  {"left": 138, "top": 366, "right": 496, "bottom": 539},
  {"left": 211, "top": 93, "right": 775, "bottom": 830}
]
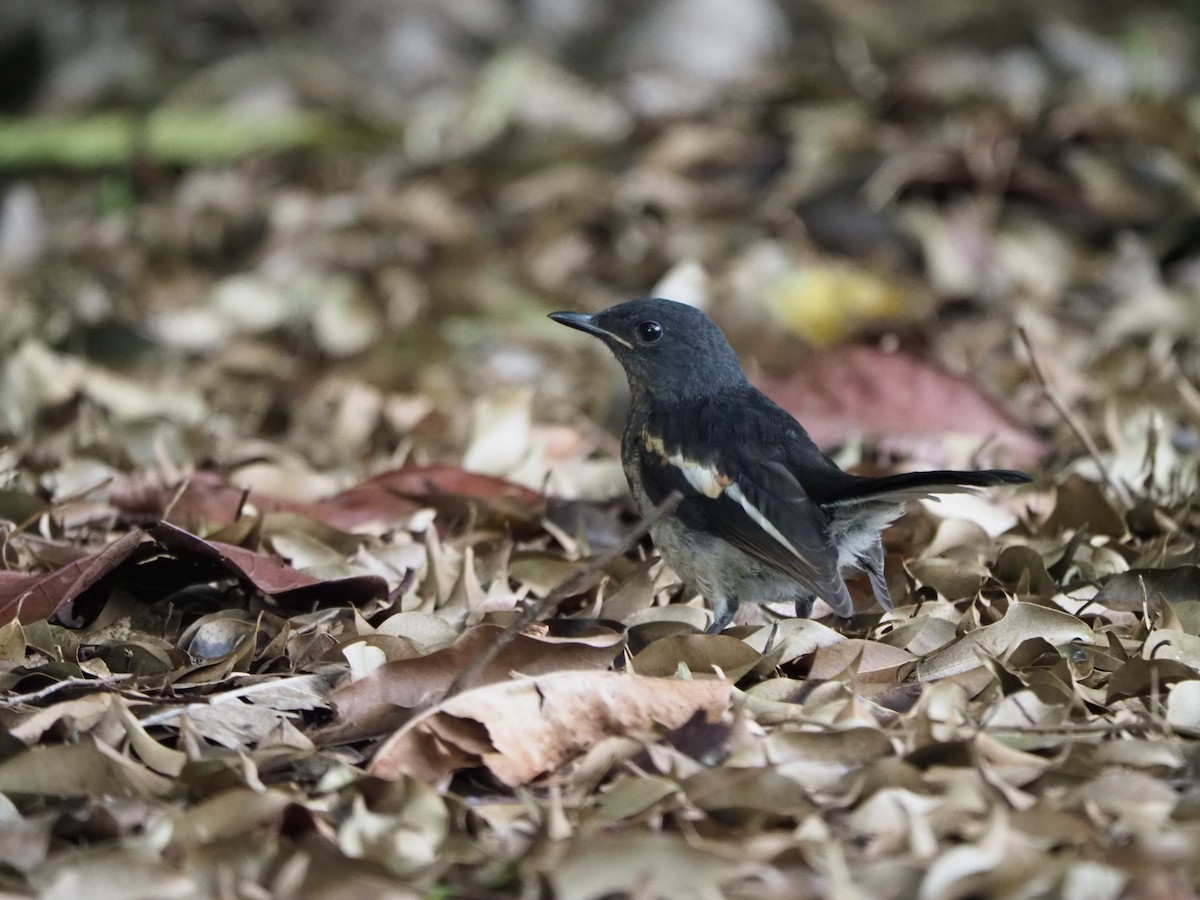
[{"left": 550, "top": 298, "right": 745, "bottom": 400}]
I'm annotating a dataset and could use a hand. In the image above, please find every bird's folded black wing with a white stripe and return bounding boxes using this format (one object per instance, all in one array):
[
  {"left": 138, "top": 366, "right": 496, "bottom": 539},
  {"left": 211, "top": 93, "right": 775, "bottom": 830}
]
[{"left": 641, "top": 433, "right": 853, "bottom": 616}]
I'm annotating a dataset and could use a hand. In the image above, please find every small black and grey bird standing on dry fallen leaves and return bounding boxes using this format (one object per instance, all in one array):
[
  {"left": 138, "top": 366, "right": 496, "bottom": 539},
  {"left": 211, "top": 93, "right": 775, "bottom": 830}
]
[{"left": 550, "top": 298, "right": 1032, "bottom": 634}]
